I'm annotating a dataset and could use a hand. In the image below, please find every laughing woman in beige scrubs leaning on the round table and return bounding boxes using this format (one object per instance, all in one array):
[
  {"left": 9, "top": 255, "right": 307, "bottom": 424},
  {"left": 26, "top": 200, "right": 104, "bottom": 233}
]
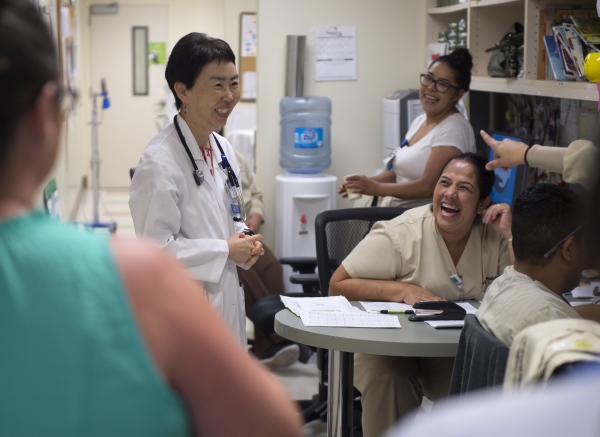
[{"left": 329, "top": 153, "right": 512, "bottom": 437}]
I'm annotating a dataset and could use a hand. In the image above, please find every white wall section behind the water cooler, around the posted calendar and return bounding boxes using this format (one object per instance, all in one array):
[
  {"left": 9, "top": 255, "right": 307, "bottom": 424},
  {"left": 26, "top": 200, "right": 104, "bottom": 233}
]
[{"left": 257, "top": 0, "right": 426, "bottom": 247}]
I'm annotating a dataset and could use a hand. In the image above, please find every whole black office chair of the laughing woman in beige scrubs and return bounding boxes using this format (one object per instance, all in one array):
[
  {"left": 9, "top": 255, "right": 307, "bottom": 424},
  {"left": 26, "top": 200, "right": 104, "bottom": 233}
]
[{"left": 301, "top": 207, "right": 406, "bottom": 424}]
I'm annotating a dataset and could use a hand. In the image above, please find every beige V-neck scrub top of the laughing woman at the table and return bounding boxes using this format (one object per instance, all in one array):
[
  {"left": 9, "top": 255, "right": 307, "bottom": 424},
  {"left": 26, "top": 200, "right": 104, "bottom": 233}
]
[{"left": 342, "top": 205, "right": 510, "bottom": 300}]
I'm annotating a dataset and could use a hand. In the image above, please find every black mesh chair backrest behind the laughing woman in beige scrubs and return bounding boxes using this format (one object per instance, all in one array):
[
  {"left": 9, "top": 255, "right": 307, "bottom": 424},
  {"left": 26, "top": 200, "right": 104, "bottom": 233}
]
[{"left": 315, "top": 207, "right": 406, "bottom": 296}]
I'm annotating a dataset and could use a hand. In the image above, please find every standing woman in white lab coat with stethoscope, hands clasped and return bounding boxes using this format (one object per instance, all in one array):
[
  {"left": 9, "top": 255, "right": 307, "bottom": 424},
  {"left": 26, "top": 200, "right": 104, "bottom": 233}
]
[{"left": 129, "top": 33, "right": 264, "bottom": 344}]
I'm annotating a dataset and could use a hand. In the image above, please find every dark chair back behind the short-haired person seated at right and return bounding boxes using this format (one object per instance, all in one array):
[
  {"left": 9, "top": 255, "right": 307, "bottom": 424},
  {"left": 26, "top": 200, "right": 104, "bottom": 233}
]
[{"left": 448, "top": 314, "right": 510, "bottom": 399}]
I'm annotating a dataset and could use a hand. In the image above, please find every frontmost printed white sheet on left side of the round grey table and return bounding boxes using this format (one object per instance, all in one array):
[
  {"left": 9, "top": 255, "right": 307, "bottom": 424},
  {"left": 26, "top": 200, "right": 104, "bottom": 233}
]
[{"left": 300, "top": 311, "right": 401, "bottom": 328}]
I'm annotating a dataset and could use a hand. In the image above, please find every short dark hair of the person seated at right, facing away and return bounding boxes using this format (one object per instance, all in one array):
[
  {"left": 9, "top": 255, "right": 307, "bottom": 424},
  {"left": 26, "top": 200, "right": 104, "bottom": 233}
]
[{"left": 512, "top": 184, "right": 584, "bottom": 266}]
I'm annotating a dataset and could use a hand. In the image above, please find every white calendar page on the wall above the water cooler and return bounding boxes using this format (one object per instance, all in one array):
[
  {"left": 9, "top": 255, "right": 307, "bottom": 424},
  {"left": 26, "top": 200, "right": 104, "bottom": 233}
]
[{"left": 314, "top": 26, "right": 357, "bottom": 81}]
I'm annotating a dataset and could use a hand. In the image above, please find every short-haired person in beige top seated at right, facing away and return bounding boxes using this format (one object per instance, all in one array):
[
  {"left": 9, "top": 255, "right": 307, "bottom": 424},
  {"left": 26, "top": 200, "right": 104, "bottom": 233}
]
[{"left": 477, "top": 184, "right": 588, "bottom": 346}]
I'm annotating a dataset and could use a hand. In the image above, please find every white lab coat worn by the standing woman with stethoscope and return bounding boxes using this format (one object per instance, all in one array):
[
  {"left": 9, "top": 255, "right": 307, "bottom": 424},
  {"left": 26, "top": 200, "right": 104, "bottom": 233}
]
[{"left": 129, "top": 115, "right": 247, "bottom": 345}]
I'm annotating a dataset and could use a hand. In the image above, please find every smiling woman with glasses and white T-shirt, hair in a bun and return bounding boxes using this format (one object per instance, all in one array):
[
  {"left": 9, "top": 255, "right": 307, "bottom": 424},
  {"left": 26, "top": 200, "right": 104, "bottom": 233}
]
[{"left": 338, "top": 48, "right": 475, "bottom": 208}]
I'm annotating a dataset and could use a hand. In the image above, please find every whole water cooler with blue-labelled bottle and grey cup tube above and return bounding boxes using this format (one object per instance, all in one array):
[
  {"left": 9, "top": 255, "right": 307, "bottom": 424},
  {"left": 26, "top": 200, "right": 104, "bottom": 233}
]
[{"left": 275, "top": 35, "right": 338, "bottom": 292}]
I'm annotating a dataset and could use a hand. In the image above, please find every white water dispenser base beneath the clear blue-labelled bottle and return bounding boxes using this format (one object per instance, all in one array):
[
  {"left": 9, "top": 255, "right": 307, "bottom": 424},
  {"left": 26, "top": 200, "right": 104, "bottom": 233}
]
[{"left": 275, "top": 173, "right": 338, "bottom": 293}]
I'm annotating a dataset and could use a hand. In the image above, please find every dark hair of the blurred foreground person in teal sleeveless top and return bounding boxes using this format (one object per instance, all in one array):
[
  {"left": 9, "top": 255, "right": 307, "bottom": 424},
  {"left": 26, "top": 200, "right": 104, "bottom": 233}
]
[{"left": 0, "top": 0, "right": 58, "bottom": 165}]
